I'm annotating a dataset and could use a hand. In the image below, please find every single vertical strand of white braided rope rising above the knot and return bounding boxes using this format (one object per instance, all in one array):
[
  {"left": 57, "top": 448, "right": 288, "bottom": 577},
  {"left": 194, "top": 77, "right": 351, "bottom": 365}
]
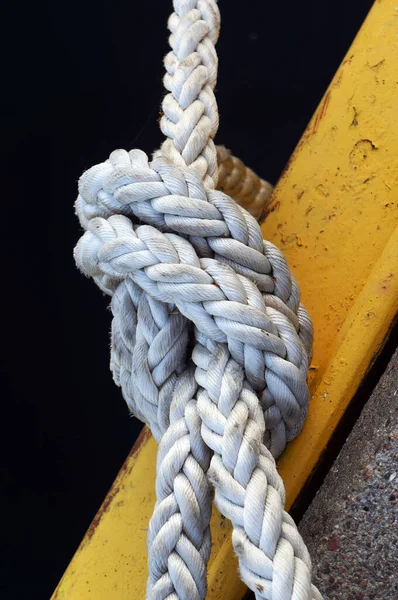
[{"left": 156, "top": 0, "right": 220, "bottom": 188}]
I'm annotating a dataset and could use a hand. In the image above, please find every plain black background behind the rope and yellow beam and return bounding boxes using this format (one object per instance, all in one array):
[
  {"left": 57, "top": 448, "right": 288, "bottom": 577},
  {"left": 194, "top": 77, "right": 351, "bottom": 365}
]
[{"left": 0, "top": 0, "right": 372, "bottom": 600}]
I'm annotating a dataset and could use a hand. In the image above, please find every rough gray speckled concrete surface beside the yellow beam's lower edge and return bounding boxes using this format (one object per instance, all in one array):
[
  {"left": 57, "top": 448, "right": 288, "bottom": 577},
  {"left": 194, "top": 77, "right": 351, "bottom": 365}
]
[{"left": 300, "top": 350, "right": 398, "bottom": 600}]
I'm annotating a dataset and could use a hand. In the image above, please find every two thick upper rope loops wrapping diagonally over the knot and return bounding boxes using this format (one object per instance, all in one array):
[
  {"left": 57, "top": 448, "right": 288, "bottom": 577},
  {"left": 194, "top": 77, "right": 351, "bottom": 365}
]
[{"left": 75, "top": 150, "right": 312, "bottom": 454}]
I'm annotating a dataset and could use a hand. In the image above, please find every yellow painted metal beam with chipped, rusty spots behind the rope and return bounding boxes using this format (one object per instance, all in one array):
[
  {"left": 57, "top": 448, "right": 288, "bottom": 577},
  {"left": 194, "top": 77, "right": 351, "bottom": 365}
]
[{"left": 53, "top": 0, "right": 398, "bottom": 600}]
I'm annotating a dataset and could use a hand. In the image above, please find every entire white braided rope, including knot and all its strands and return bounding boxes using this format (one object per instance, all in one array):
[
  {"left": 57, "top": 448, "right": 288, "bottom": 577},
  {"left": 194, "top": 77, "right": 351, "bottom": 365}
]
[{"left": 75, "top": 0, "right": 321, "bottom": 600}]
